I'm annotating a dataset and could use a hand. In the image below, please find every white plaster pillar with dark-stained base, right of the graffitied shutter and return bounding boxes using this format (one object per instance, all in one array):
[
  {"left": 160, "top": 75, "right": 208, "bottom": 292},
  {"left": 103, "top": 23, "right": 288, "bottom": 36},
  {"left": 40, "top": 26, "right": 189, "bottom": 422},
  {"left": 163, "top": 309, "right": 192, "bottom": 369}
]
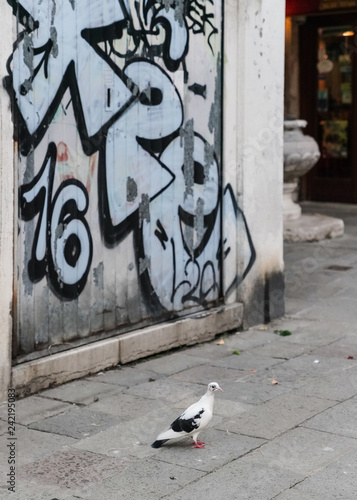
[{"left": 224, "top": 0, "right": 285, "bottom": 325}]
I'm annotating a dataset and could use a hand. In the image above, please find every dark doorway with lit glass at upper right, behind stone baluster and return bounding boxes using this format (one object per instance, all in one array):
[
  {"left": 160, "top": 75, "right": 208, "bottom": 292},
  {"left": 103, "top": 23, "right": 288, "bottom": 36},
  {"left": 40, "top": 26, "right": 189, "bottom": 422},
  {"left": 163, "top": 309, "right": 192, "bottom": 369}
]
[{"left": 300, "top": 13, "right": 357, "bottom": 203}]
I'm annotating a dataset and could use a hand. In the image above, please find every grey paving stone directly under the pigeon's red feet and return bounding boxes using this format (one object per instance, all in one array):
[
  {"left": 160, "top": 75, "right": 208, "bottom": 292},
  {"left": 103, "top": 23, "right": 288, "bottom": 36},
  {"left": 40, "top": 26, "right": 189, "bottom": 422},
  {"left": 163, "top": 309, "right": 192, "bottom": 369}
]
[{"left": 153, "top": 429, "right": 265, "bottom": 472}]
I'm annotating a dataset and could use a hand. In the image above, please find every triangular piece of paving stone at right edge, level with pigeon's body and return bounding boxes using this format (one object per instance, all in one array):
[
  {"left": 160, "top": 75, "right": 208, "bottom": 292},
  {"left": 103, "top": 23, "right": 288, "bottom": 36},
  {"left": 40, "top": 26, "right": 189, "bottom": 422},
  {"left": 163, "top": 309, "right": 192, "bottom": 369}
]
[{"left": 304, "top": 398, "right": 357, "bottom": 438}]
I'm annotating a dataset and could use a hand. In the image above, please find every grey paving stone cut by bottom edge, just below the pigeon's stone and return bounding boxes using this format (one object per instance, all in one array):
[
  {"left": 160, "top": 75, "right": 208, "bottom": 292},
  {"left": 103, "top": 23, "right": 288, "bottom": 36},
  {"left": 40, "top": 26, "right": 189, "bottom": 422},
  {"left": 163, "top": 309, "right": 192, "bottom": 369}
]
[{"left": 166, "top": 457, "right": 303, "bottom": 500}]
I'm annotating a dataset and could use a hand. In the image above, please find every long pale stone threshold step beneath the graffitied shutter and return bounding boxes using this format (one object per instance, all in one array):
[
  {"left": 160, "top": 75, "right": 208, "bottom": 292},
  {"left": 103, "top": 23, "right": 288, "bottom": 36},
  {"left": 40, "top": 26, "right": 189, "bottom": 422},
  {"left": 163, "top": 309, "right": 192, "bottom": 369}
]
[{"left": 11, "top": 303, "right": 243, "bottom": 396}]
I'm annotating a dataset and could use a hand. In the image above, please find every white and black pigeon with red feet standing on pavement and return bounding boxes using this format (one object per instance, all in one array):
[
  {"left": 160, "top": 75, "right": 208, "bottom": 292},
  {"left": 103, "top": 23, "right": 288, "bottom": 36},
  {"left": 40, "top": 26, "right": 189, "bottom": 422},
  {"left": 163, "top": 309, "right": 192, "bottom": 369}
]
[{"left": 151, "top": 382, "right": 223, "bottom": 448}]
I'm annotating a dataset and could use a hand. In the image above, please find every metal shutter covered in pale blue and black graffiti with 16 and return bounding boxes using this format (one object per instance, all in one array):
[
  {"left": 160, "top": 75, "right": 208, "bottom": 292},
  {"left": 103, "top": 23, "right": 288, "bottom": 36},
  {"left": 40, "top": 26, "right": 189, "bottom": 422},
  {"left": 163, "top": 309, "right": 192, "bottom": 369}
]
[{"left": 4, "top": 0, "right": 254, "bottom": 356}]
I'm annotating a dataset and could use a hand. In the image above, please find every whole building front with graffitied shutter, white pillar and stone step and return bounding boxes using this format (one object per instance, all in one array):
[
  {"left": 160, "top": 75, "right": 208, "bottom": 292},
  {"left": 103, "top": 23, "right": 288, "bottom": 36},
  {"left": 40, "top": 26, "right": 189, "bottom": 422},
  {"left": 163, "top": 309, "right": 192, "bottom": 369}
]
[{"left": 0, "top": 0, "right": 285, "bottom": 399}]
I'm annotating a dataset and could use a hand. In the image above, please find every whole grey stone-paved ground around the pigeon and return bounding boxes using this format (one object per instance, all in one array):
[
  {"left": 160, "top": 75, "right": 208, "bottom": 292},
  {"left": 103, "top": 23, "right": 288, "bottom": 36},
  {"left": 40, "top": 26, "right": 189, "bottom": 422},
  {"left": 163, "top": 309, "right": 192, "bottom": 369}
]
[{"left": 0, "top": 204, "right": 357, "bottom": 500}]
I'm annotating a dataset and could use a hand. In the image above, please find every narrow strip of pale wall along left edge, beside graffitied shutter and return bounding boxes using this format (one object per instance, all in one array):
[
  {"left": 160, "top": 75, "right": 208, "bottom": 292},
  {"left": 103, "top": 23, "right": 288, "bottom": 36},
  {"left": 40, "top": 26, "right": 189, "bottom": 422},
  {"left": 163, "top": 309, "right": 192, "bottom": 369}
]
[{"left": 0, "top": 9, "right": 14, "bottom": 402}]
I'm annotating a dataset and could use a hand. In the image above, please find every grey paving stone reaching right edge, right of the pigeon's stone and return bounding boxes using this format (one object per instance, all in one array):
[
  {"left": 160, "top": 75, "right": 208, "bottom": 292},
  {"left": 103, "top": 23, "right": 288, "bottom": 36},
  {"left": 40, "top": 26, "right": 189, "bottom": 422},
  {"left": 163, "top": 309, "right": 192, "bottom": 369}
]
[{"left": 242, "top": 427, "right": 357, "bottom": 477}]
